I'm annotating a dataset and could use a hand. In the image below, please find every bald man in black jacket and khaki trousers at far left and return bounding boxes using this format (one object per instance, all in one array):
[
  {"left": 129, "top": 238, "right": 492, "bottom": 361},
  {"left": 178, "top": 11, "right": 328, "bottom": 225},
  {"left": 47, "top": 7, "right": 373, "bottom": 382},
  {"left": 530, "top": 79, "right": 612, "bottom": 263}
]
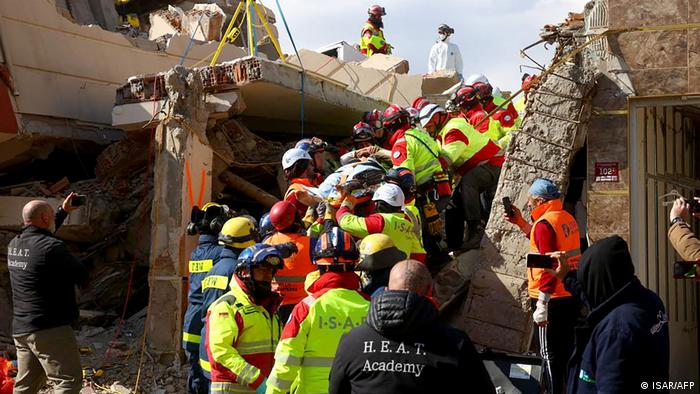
[{"left": 7, "top": 193, "right": 88, "bottom": 394}]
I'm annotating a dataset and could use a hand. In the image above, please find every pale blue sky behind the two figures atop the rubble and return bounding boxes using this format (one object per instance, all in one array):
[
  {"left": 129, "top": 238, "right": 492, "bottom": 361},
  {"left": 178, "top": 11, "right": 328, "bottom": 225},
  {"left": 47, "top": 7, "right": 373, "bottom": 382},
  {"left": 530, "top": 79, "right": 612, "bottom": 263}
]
[{"left": 270, "top": 0, "right": 587, "bottom": 90}]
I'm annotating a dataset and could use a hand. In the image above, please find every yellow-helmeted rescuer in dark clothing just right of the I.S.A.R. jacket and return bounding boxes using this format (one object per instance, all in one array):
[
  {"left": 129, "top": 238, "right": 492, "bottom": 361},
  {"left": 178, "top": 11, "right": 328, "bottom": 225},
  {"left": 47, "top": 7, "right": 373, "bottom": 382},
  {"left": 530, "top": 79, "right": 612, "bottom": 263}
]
[{"left": 356, "top": 234, "right": 406, "bottom": 296}]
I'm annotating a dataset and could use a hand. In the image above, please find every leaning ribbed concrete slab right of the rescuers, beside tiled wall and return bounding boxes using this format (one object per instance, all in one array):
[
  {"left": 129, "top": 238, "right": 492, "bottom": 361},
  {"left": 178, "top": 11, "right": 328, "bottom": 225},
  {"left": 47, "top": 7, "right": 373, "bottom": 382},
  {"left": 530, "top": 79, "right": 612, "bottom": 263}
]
[{"left": 435, "top": 48, "right": 594, "bottom": 353}]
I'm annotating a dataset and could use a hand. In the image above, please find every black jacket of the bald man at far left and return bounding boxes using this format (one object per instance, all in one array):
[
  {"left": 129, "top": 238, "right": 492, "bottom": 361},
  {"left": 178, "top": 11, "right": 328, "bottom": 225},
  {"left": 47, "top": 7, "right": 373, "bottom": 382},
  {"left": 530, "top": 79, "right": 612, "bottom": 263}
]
[{"left": 7, "top": 210, "right": 88, "bottom": 335}]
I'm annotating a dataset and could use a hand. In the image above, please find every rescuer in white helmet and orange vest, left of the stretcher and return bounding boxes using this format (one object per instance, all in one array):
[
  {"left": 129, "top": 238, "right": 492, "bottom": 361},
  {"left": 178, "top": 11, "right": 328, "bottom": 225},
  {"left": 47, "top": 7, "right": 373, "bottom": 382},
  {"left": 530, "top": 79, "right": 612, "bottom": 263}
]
[{"left": 282, "top": 148, "right": 321, "bottom": 218}]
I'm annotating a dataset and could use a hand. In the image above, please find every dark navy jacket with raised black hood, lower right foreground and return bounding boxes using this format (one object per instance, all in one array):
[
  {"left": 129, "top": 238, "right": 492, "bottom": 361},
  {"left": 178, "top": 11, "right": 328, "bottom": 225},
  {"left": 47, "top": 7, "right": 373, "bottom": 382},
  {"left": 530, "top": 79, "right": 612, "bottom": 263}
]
[{"left": 567, "top": 237, "right": 669, "bottom": 394}]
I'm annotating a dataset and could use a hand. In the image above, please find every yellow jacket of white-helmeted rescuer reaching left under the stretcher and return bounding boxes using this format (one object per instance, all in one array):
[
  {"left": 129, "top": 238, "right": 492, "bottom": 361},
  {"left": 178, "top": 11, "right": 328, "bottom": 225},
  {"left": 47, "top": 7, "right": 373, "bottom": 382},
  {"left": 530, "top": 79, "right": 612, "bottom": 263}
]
[{"left": 336, "top": 208, "right": 425, "bottom": 261}]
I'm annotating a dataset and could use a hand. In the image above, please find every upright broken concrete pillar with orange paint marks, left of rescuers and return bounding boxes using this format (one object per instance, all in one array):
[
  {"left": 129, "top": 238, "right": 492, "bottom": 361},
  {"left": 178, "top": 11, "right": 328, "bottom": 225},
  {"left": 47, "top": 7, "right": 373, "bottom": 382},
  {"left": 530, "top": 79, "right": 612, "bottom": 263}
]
[{"left": 146, "top": 67, "right": 213, "bottom": 359}]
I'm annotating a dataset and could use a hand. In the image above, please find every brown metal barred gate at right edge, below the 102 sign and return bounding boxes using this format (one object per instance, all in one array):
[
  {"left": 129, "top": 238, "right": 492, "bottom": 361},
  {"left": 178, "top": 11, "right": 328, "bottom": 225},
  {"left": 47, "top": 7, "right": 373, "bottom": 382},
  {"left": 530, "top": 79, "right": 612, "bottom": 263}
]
[{"left": 629, "top": 97, "right": 700, "bottom": 382}]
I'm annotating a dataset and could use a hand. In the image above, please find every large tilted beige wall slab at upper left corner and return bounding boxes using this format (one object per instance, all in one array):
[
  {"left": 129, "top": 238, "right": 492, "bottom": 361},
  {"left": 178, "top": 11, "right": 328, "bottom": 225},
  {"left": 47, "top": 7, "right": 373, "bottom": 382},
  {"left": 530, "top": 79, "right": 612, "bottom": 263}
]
[{"left": 0, "top": 0, "right": 244, "bottom": 132}]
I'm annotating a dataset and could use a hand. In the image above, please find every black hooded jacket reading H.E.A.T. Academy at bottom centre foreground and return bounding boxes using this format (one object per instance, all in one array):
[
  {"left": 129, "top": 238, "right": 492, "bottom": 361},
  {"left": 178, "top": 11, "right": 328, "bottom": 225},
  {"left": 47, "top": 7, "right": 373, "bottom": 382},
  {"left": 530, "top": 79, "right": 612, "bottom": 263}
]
[{"left": 329, "top": 290, "right": 495, "bottom": 394}]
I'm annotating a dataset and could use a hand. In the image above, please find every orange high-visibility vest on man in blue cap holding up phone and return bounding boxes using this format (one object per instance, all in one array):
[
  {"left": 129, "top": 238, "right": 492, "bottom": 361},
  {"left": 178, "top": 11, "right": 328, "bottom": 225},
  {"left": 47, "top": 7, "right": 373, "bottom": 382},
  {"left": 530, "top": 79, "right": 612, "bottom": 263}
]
[{"left": 527, "top": 199, "right": 581, "bottom": 298}]
